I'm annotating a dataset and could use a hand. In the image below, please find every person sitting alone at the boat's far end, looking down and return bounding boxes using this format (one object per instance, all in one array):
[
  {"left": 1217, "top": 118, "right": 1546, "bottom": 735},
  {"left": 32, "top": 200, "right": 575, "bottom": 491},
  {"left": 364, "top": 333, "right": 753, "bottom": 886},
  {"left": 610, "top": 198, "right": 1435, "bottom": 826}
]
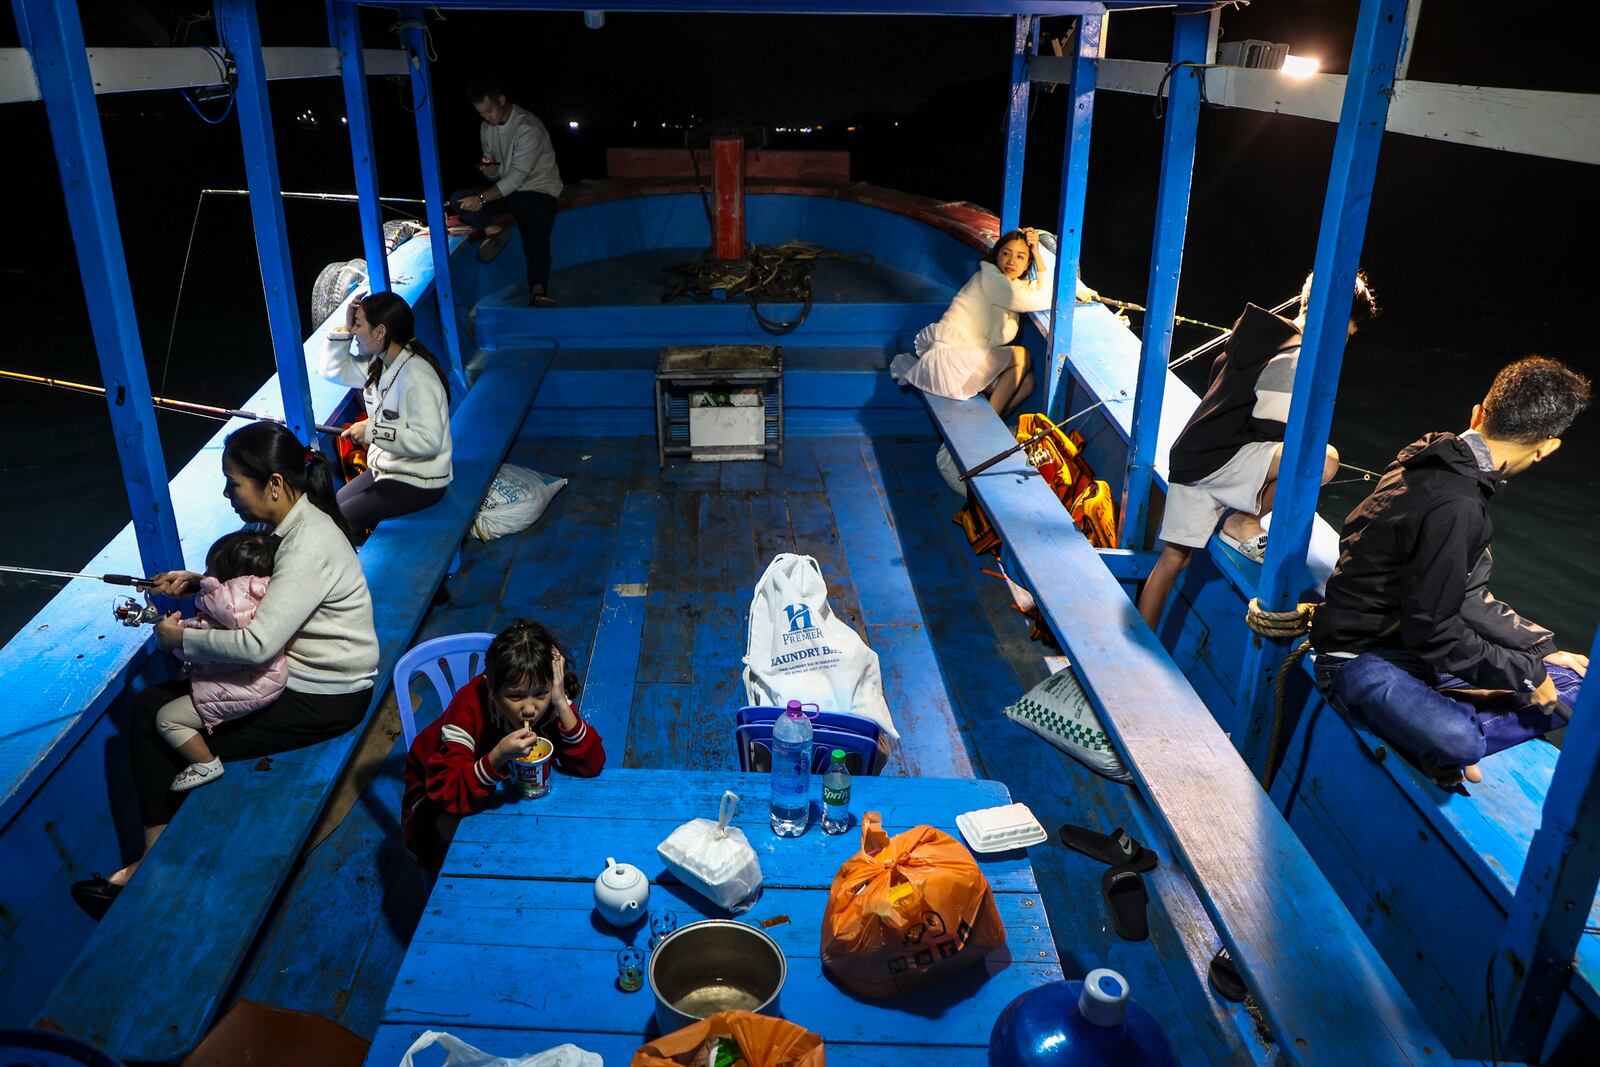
[{"left": 448, "top": 82, "right": 562, "bottom": 307}]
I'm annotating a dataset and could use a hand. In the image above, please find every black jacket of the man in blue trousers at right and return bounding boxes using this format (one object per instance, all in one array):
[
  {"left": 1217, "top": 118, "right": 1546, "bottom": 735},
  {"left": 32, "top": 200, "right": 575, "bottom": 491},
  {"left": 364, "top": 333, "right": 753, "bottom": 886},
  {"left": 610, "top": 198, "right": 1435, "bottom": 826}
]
[{"left": 1310, "top": 434, "right": 1555, "bottom": 691}]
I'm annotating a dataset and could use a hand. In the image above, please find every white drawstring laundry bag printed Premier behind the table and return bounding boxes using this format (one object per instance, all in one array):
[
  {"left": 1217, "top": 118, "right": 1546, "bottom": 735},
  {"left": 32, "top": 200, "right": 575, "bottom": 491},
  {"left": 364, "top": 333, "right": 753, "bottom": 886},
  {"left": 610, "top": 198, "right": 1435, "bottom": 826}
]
[{"left": 744, "top": 552, "right": 899, "bottom": 741}]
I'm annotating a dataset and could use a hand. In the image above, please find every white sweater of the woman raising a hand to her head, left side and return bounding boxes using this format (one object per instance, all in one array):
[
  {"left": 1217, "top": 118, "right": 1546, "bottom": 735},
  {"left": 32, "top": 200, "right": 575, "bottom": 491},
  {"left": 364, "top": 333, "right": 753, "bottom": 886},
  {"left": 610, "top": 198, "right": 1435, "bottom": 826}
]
[{"left": 320, "top": 333, "right": 451, "bottom": 490}]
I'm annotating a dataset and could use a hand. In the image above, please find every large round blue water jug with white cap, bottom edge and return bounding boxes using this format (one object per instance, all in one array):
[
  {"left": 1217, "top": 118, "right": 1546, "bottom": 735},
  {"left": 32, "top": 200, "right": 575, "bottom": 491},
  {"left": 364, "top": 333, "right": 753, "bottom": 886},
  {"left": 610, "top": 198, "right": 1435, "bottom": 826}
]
[{"left": 989, "top": 968, "right": 1178, "bottom": 1067}]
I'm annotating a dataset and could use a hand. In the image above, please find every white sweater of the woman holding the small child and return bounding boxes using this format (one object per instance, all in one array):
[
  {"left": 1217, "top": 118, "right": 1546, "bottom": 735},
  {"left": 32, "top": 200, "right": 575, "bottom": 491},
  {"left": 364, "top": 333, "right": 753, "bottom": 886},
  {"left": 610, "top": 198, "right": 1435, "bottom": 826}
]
[{"left": 182, "top": 496, "right": 378, "bottom": 693}]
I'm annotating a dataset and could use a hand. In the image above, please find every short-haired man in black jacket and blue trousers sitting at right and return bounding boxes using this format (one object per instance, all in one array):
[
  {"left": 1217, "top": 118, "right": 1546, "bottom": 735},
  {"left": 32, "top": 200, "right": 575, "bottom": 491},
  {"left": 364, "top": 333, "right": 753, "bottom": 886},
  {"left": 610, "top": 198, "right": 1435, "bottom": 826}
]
[{"left": 1310, "top": 357, "right": 1589, "bottom": 785}]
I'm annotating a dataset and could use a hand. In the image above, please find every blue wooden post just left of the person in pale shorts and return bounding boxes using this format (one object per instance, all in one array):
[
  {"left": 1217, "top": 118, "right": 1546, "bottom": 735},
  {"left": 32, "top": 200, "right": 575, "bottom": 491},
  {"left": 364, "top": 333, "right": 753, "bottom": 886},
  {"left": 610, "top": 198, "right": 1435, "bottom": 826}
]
[{"left": 1122, "top": 11, "right": 1216, "bottom": 550}]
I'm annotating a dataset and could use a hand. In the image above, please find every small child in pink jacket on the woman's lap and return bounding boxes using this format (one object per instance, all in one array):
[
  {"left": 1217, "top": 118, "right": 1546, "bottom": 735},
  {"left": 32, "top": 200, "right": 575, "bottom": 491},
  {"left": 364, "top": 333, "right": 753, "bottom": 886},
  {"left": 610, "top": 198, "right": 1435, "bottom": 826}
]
[{"left": 155, "top": 530, "right": 290, "bottom": 792}]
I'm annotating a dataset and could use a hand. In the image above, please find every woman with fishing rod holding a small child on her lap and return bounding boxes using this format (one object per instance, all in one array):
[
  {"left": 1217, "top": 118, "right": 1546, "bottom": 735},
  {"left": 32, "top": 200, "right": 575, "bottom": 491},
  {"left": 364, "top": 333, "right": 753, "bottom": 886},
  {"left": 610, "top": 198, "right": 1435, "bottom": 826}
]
[{"left": 72, "top": 422, "right": 378, "bottom": 918}]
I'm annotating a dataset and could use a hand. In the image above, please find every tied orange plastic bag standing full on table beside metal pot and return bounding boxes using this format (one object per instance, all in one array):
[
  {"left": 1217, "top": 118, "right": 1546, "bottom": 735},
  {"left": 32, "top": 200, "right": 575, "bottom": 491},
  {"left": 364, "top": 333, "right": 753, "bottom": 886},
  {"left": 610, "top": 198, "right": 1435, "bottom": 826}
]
[{"left": 822, "top": 811, "right": 1005, "bottom": 997}]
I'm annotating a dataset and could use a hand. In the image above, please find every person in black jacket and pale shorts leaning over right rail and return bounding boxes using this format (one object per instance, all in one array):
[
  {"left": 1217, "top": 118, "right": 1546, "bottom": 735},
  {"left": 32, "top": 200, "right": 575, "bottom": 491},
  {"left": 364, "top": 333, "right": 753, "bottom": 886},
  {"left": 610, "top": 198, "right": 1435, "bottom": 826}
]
[{"left": 1139, "top": 274, "right": 1378, "bottom": 629}]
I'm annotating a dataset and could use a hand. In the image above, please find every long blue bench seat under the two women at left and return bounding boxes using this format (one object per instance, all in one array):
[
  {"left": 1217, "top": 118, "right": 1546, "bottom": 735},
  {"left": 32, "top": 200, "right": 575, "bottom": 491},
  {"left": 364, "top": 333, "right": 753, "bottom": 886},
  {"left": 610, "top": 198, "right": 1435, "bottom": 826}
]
[{"left": 35, "top": 352, "right": 547, "bottom": 1062}]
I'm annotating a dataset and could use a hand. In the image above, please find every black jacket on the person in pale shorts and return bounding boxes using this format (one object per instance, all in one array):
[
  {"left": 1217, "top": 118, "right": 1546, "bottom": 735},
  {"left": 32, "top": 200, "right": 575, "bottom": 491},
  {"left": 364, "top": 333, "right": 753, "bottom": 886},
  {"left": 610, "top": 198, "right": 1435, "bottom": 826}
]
[{"left": 1166, "top": 304, "right": 1301, "bottom": 485}]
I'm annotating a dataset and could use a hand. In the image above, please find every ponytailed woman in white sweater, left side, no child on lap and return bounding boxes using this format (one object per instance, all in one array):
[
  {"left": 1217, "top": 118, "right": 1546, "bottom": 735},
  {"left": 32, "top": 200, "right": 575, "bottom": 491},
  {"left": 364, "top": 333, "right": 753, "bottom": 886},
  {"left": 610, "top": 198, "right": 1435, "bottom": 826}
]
[{"left": 322, "top": 293, "right": 451, "bottom": 544}]
